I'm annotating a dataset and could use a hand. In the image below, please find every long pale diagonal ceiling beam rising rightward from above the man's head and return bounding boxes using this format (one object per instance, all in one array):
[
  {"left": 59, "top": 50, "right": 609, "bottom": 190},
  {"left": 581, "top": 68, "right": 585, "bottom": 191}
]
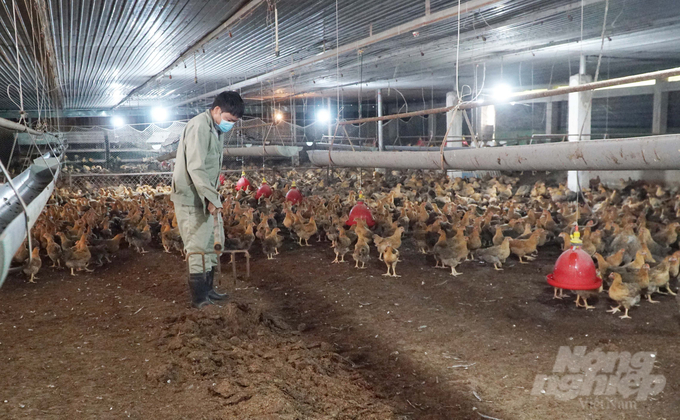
[{"left": 165, "top": 0, "right": 503, "bottom": 106}]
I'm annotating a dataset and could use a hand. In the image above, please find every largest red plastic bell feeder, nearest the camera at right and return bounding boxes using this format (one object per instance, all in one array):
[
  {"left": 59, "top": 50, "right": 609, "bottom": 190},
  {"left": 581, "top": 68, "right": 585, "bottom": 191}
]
[{"left": 546, "top": 231, "right": 602, "bottom": 290}]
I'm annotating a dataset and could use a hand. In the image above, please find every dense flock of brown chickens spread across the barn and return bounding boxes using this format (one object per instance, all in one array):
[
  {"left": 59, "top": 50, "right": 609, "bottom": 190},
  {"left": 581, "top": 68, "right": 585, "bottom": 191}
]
[{"left": 14, "top": 170, "right": 680, "bottom": 318}]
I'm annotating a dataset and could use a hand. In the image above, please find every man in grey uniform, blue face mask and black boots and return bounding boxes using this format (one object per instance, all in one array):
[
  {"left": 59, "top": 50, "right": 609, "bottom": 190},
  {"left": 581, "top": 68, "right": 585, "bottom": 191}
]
[{"left": 171, "top": 92, "right": 244, "bottom": 308}]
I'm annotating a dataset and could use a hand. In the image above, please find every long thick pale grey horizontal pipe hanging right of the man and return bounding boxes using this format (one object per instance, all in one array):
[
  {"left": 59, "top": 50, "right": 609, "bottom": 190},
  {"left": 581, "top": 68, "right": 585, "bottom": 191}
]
[{"left": 307, "top": 134, "right": 680, "bottom": 171}]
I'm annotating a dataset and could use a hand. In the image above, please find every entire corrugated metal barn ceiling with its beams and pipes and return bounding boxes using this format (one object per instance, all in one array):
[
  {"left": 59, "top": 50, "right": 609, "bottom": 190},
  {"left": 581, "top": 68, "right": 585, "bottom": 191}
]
[{"left": 0, "top": 0, "right": 680, "bottom": 115}]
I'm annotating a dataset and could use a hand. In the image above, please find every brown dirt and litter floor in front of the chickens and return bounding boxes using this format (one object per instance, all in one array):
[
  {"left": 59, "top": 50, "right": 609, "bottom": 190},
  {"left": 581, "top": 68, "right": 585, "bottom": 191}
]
[{"left": 0, "top": 241, "right": 680, "bottom": 420}]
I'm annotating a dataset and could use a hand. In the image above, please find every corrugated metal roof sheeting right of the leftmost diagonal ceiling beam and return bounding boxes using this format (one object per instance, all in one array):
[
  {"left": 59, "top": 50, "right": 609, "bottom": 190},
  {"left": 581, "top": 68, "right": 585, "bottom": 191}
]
[{"left": 125, "top": 0, "right": 680, "bottom": 109}]
